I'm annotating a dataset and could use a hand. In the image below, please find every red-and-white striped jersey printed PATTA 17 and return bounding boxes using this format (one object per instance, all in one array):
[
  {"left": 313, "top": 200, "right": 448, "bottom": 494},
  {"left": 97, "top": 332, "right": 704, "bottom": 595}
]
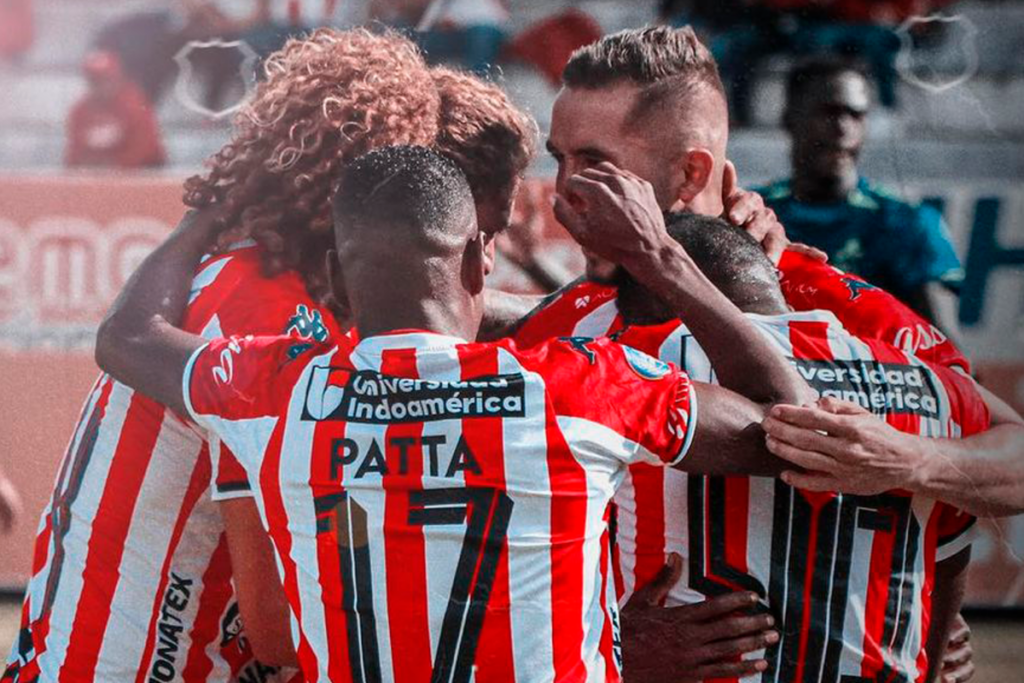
[{"left": 184, "top": 331, "right": 696, "bottom": 683}]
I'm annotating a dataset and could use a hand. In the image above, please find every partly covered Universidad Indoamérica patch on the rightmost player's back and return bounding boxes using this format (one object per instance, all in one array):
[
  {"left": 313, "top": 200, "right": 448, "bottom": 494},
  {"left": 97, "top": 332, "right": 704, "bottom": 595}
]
[{"left": 794, "top": 359, "right": 941, "bottom": 419}]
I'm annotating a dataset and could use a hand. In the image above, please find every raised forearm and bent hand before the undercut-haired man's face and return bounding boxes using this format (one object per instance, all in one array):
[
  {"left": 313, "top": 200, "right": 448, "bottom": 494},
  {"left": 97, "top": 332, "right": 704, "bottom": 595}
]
[{"left": 555, "top": 163, "right": 816, "bottom": 404}]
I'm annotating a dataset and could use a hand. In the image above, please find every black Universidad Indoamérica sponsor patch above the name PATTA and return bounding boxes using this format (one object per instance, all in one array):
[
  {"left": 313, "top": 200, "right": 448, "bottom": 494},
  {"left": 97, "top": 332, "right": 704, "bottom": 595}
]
[{"left": 302, "top": 368, "right": 525, "bottom": 424}]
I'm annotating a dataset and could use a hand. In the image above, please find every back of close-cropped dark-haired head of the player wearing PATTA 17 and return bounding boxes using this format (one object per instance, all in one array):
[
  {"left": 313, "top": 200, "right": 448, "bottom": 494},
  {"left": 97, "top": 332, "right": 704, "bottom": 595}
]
[{"left": 332, "top": 145, "right": 484, "bottom": 338}]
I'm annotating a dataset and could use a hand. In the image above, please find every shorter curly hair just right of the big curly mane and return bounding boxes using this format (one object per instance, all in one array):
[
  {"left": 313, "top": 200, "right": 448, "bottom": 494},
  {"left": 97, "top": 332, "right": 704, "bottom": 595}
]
[{"left": 433, "top": 67, "right": 538, "bottom": 211}]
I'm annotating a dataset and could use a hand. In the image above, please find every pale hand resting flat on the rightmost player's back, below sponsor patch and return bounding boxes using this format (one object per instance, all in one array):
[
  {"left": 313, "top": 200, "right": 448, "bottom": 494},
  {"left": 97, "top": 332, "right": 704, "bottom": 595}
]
[{"left": 761, "top": 398, "right": 929, "bottom": 496}]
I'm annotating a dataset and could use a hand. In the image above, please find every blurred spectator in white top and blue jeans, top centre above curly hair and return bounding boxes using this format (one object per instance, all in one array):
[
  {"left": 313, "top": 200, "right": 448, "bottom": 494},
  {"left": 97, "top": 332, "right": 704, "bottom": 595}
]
[{"left": 369, "top": 0, "right": 509, "bottom": 75}]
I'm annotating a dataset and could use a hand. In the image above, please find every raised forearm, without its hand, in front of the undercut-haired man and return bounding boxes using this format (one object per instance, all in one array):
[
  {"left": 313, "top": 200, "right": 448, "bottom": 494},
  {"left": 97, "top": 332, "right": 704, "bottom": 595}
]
[{"left": 630, "top": 243, "right": 814, "bottom": 404}]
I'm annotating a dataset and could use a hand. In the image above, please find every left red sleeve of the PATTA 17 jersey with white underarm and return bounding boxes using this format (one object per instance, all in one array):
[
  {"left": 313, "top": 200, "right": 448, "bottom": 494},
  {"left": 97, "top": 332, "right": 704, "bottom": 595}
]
[{"left": 182, "top": 336, "right": 314, "bottom": 479}]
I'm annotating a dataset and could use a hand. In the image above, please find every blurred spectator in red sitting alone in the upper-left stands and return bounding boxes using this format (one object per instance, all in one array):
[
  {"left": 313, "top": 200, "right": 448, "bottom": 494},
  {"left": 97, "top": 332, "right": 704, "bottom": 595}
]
[{"left": 65, "top": 51, "right": 166, "bottom": 169}]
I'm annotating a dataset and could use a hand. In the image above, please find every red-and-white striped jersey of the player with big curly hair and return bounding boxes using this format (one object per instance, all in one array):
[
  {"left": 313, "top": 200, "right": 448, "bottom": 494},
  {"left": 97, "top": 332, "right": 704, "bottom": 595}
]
[{"left": 3, "top": 247, "right": 337, "bottom": 683}]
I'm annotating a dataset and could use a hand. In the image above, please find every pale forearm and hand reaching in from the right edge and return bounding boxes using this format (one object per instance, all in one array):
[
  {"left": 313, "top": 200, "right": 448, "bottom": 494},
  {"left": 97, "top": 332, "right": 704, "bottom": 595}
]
[{"left": 763, "top": 386, "right": 1024, "bottom": 517}]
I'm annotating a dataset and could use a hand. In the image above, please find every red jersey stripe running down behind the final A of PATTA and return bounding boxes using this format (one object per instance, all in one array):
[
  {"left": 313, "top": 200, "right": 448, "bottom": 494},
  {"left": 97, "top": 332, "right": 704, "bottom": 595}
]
[{"left": 459, "top": 346, "right": 516, "bottom": 681}]
